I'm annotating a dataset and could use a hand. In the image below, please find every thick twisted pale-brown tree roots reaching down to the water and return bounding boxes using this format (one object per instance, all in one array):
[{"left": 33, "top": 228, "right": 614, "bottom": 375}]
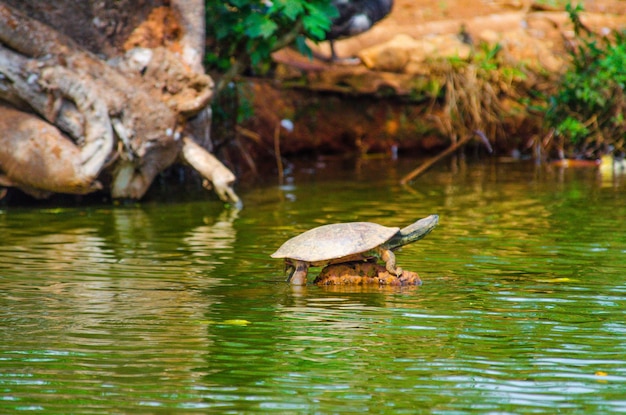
[{"left": 0, "top": 2, "right": 240, "bottom": 204}]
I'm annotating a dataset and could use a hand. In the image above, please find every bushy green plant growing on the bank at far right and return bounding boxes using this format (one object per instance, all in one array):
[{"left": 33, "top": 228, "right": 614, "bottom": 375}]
[{"left": 545, "top": 5, "right": 626, "bottom": 157}]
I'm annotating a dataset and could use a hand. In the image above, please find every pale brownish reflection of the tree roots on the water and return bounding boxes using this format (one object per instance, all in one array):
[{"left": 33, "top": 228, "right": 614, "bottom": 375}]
[{"left": 0, "top": 209, "right": 241, "bottom": 412}]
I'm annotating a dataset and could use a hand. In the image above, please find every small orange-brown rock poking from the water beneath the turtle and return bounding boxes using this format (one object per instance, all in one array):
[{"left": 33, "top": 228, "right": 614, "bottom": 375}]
[{"left": 313, "top": 262, "right": 422, "bottom": 286}]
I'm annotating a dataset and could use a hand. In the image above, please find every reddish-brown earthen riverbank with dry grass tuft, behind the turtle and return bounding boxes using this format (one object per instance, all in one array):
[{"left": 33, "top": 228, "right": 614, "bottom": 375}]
[{"left": 238, "top": 0, "right": 626, "bottom": 163}]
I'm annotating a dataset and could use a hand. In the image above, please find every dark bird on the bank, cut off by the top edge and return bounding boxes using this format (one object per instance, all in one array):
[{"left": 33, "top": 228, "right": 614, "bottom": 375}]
[{"left": 326, "top": 0, "right": 393, "bottom": 61}]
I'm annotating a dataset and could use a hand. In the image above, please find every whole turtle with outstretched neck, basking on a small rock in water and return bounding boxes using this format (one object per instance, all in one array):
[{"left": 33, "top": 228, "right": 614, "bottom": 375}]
[{"left": 270, "top": 215, "right": 439, "bottom": 285}]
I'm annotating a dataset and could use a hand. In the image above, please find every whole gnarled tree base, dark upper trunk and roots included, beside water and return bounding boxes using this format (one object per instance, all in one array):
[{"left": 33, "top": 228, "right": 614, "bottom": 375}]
[{"left": 0, "top": 0, "right": 240, "bottom": 204}]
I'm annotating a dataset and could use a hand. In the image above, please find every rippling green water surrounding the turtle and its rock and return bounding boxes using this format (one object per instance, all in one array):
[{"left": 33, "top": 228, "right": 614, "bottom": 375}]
[{"left": 0, "top": 160, "right": 626, "bottom": 414}]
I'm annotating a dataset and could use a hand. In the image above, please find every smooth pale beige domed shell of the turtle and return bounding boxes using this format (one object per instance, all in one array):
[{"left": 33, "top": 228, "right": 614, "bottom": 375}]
[{"left": 271, "top": 222, "right": 400, "bottom": 262}]
